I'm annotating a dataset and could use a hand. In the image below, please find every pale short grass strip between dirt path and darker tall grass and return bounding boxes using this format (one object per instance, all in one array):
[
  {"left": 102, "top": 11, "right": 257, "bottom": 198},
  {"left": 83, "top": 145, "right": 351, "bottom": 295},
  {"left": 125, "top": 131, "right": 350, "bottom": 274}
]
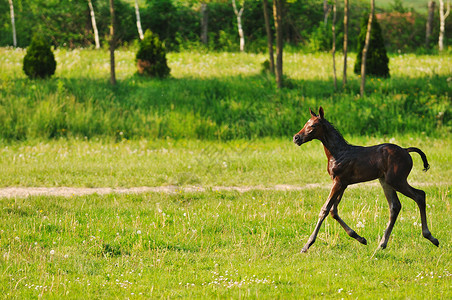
[{"left": 0, "top": 136, "right": 452, "bottom": 188}]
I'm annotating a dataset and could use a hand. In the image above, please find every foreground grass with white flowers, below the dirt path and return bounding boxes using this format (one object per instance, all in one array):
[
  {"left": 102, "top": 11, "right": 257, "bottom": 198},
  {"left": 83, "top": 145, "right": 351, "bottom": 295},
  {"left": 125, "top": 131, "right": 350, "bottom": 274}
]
[{"left": 0, "top": 185, "right": 452, "bottom": 299}]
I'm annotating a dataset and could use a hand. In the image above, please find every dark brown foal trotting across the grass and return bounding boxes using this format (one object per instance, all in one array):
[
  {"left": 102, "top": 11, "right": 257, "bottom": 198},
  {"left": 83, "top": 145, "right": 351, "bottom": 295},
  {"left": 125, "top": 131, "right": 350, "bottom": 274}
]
[{"left": 293, "top": 107, "right": 439, "bottom": 252}]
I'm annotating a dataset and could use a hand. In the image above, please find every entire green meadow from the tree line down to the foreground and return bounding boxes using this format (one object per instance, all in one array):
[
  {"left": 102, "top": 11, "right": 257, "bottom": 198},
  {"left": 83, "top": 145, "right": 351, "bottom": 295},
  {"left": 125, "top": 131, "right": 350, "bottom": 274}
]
[{"left": 0, "top": 48, "right": 452, "bottom": 299}]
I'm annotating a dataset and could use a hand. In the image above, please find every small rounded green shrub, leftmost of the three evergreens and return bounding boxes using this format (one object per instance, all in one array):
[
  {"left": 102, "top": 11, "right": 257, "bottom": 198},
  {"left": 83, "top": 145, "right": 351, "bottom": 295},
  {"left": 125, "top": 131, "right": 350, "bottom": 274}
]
[{"left": 23, "top": 35, "right": 56, "bottom": 79}]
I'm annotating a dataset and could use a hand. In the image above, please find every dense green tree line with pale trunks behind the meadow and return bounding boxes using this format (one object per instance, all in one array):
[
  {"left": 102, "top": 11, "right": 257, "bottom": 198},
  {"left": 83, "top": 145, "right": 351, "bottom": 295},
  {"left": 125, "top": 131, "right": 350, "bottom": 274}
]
[{"left": 0, "top": 0, "right": 452, "bottom": 52}]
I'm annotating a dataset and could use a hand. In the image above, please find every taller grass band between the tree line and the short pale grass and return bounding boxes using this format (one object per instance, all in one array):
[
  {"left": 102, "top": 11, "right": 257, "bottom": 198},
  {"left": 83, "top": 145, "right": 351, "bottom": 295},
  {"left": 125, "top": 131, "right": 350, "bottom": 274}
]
[{"left": 0, "top": 49, "right": 452, "bottom": 140}]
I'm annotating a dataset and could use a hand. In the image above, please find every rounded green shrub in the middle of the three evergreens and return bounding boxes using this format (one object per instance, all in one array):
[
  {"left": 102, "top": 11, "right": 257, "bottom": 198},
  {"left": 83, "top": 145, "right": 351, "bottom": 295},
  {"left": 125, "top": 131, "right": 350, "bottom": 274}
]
[{"left": 136, "top": 30, "right": 170, "bottom": 77}]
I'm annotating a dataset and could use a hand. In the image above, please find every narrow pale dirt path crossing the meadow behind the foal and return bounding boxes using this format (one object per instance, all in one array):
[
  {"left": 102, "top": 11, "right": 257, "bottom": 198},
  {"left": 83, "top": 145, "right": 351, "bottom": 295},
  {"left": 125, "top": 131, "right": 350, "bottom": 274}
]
[{"left": 0, "top": 182, "right": 446, "bottom": 198}]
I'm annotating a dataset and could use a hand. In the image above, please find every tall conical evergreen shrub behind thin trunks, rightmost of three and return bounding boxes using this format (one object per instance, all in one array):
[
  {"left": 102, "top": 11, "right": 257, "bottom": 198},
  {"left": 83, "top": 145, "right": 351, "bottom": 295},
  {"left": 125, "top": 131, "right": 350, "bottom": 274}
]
[{"left": 354, "top": 16, "right": 389, "bottom": 77}]
